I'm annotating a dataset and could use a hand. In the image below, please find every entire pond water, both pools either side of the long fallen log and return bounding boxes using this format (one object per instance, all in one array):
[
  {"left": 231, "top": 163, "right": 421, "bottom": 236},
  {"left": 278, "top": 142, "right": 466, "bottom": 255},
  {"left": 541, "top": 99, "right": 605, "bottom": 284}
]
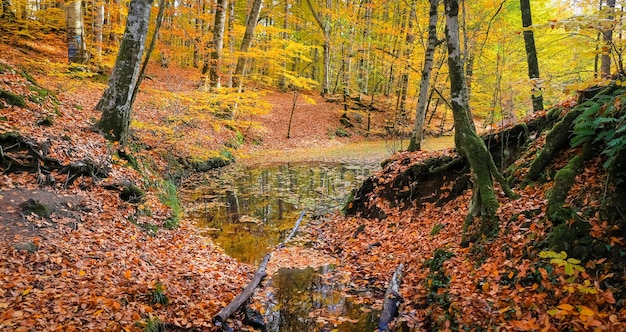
[{"left": 186, "top": 163, "right": 379, "bottom": 331}]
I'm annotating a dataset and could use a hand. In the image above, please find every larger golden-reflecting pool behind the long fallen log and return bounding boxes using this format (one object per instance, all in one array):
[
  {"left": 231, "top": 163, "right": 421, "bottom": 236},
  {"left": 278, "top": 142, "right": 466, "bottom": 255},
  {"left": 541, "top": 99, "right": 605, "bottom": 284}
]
[{"left": 185, "top": 164, "right": 377, "bottom": 264}]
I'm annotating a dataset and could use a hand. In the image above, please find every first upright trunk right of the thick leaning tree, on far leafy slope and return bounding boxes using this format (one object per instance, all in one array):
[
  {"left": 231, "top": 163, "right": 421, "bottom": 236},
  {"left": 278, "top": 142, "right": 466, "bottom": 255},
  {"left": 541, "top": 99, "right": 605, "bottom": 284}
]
[{"left": 203, "top": 0, "right": 228, "bottom": 89}]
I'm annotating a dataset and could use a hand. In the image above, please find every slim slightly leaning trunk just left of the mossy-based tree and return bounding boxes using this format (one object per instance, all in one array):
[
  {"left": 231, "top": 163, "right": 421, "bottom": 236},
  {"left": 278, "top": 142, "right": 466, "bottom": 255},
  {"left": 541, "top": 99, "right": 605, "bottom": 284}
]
[{"left": 408, "top": 0, "right": 439, "bottom": 151}]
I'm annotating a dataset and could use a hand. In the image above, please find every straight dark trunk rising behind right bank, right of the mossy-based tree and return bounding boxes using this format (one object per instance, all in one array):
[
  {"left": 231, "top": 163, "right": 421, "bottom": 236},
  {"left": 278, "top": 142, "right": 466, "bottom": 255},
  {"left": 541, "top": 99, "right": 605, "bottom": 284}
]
[{"left": 520, "top": 0, "right": 540, "bottom": 112}]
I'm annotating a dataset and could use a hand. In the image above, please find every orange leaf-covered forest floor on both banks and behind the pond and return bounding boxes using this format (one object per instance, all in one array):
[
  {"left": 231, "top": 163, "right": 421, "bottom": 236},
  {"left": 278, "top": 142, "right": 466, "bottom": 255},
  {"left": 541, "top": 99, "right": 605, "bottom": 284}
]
[{"left": 0, "top": 29, "right": 626, "bottom": 331}]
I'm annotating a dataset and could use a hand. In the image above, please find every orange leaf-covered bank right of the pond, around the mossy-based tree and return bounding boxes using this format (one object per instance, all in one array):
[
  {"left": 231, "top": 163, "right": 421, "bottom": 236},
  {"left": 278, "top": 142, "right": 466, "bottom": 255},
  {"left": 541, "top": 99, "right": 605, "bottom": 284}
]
[{"left": 306, "top": 123, "right": 626, "bottom": 331}]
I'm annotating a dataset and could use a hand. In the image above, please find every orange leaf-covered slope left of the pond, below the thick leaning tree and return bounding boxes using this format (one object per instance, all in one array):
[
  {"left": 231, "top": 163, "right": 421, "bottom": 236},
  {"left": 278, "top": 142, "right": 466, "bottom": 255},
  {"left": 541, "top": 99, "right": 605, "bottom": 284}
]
[{"left": 0, "top": 62, "right": 253, "bottom": 331}]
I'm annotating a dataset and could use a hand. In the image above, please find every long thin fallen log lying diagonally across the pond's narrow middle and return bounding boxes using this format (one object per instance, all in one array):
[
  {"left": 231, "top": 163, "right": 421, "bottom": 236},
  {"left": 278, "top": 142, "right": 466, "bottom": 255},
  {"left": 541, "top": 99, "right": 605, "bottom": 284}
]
[{"left": 212, "top": 211, "right": 305, "bottom": 328}]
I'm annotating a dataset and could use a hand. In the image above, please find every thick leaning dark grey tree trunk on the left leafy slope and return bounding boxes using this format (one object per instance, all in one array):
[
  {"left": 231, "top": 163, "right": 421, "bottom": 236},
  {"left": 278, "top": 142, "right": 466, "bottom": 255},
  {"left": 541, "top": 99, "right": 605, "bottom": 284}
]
[{"left": 96, "top": 0, "right": 152, "bottom": 145}]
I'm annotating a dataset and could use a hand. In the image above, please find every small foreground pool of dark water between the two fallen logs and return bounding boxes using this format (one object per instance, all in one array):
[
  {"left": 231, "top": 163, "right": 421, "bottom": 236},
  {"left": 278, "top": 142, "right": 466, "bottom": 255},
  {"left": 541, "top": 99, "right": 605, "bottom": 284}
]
[{"left": 266, "top": 266, "right": 379, "bottom": 332}]
